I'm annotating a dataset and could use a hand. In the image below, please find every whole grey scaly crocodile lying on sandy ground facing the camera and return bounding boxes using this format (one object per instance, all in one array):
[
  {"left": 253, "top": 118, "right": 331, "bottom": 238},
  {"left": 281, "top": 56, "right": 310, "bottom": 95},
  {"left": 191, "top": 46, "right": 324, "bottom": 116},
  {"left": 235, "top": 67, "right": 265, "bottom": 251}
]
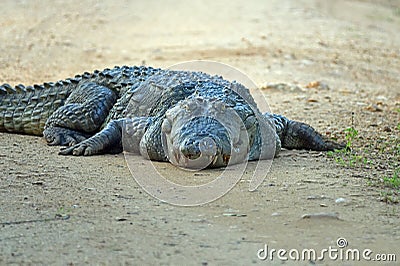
[{"left": 0, "top": 66, "right": 343, "bottom": 169}]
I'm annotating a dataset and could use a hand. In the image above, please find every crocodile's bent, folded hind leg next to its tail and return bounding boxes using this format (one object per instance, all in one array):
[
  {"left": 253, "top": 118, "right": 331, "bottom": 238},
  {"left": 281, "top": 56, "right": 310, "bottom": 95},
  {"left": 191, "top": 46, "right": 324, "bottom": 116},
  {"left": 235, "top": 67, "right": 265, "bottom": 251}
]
[{"left": 43, "top": 83, "right": 117, "bottom": 146}]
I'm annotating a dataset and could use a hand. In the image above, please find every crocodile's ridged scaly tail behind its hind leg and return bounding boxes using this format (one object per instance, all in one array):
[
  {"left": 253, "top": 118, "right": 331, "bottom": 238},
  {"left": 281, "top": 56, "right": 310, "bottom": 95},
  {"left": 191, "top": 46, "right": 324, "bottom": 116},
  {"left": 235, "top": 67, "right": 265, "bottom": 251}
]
[{"left": 0, "top": 79, "right": 78, "bottom": 135}]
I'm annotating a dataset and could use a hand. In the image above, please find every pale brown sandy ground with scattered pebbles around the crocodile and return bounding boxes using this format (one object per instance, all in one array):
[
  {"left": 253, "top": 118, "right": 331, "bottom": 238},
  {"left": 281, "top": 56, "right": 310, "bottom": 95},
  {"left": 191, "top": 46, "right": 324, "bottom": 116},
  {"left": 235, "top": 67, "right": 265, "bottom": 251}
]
[{"left": 0, "top": 0, "right": 400, "bottom": 265}]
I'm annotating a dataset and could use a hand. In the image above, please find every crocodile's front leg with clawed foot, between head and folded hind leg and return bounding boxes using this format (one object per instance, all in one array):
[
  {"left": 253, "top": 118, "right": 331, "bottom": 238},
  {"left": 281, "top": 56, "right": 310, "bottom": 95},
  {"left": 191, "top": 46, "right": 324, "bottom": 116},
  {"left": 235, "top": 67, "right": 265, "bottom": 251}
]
[{"left": 59, "top": 117, "right": 152, "bottom": 156}]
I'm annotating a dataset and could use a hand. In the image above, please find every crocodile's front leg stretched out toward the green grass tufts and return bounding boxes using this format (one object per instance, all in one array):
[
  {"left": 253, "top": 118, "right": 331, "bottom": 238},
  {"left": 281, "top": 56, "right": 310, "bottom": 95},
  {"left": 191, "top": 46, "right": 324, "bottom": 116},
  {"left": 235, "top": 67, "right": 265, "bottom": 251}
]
[{"left": 266, "top": 114, "right": 346, "bottom": 151}]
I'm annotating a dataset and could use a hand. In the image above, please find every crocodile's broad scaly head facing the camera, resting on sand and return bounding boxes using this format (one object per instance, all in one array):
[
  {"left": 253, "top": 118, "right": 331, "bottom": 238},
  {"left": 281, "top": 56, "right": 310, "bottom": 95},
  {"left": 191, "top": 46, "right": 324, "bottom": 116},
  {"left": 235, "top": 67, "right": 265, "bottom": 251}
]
[{"left": 161, "top": 96, "right": 250, "bottom": 170}]
